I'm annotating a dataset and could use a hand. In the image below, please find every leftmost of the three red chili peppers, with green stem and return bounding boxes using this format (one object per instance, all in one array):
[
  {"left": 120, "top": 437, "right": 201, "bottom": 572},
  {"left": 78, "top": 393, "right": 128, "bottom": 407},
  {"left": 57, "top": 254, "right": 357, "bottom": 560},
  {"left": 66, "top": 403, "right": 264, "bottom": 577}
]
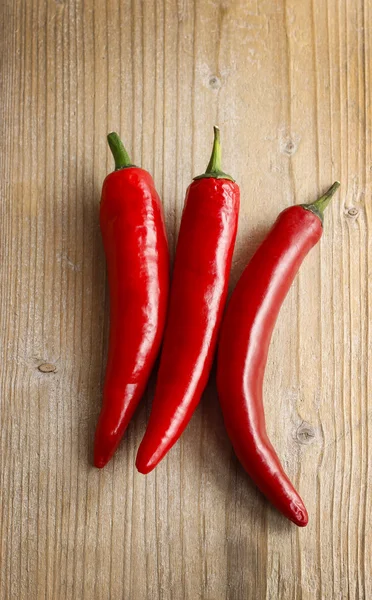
[{"left": 94, "top": 133, "right": 169, "bottom": 467}]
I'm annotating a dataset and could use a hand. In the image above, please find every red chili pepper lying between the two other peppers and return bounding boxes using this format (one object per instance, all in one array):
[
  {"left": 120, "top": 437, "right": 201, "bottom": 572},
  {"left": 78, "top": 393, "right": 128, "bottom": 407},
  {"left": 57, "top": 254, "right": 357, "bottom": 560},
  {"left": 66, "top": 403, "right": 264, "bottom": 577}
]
[{"left": 136, "top": 127, "right": 240, "bottom": 473}]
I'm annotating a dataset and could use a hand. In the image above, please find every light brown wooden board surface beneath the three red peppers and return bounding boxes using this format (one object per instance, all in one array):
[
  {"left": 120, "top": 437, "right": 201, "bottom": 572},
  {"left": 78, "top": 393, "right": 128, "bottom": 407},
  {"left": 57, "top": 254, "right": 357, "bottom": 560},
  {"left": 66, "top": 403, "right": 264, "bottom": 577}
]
[{"left": 0, "top": 0, "right": 372, "bottom": 600}]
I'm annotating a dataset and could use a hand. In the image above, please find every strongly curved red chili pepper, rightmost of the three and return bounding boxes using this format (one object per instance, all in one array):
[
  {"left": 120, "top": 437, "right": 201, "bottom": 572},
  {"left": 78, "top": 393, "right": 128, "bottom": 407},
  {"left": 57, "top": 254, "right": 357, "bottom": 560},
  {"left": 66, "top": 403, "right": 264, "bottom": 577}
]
[{"left": 217, "top": 182, "right": 340, "bottom": 527}]
